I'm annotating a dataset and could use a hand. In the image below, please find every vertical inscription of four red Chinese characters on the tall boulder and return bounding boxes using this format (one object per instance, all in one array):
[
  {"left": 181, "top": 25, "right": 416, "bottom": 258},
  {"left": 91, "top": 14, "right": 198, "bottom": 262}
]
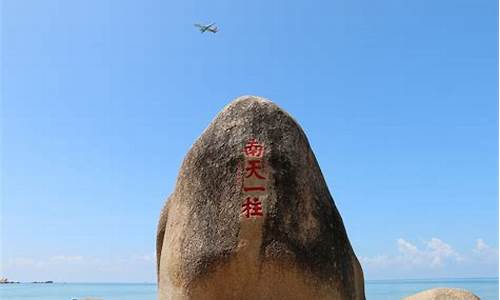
[{"left": 241, "top": 139, "right": 266, "bottom": 218}]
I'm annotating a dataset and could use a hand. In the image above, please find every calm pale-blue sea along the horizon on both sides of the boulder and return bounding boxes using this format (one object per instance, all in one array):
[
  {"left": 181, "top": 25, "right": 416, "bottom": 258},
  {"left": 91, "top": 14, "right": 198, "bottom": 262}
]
[{"left": 0, "top": 278, "right": 498, "bottom": 300}]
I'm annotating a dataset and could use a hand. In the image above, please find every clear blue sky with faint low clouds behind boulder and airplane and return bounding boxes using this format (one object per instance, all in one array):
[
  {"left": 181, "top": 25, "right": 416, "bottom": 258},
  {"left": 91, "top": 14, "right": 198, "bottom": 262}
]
[{"left": 0, "top": 0, "right": 498, "bottom": 281}]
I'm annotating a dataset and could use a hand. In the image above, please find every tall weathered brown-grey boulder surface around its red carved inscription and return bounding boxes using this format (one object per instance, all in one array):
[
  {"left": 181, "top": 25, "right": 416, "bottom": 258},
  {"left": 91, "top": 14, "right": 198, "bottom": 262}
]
[{"left": 157, "top": 96, "right": 365, "bottom": 300}]
